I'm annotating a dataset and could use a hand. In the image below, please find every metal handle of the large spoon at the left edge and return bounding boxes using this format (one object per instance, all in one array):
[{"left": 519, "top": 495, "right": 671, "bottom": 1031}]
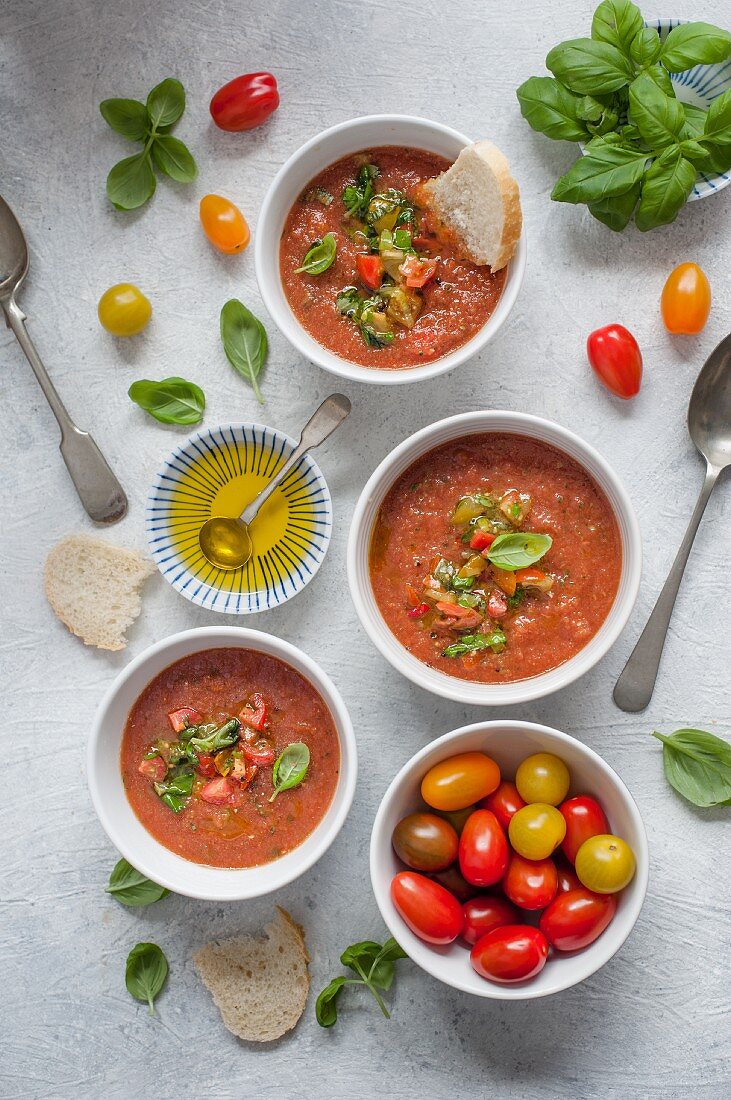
[{"left": 2, "top": 298, "right": 128, "bottom": 524}]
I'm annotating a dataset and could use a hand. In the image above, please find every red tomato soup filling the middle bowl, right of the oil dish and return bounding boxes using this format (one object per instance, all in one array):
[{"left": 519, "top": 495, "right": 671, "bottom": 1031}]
[{"left": 370, "top": 432, "right": 622, "bottom": 683}]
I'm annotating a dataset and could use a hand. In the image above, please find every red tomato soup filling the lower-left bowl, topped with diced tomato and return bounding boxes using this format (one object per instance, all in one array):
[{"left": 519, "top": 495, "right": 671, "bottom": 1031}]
[{"left": 120, "top": 649, "right": 340, "bottom": 867}]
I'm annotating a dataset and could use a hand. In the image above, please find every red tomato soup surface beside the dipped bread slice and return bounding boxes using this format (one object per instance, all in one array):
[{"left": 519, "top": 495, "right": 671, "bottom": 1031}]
[{"left": 279, "top": 146, "right": 506, "bottom": 370}]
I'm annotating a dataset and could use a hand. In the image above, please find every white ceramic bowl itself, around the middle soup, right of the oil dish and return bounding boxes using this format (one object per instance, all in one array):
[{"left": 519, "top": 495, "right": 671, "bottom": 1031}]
[{"left": 347, "top": 410, "right": 642, "bottom": 706}]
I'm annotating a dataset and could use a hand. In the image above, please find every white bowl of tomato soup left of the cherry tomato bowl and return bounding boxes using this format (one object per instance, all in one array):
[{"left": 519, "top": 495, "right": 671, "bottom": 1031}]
[{"left": 88, "top": 627, "right": 357, "bottom": 901}]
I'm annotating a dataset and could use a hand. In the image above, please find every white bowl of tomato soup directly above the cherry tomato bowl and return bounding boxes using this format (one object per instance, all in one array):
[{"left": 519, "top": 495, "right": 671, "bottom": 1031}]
[{"left": 347, "top": 411, "right": 641, "bottom": 706}]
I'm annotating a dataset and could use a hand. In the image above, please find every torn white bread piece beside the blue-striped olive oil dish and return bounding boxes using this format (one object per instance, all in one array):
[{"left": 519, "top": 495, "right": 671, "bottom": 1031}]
[{"left": 43, "top": 535, "right": 155, "bottom": 649}]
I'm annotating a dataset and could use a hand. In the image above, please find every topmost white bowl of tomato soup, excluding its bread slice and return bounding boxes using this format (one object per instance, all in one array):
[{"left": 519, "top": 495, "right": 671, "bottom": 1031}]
[{"left": 255, "top": 116, "right": 525, "bottom": 385}]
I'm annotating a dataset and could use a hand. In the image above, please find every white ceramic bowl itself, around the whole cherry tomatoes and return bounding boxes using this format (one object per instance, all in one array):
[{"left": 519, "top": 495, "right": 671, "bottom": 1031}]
[{"left": 370, "top": 722, "right": 650, "bottom": 1001}]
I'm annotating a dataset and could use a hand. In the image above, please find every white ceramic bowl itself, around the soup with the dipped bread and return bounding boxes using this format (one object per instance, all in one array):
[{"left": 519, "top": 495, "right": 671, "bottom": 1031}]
[{"left": 254, "top": 114, "right": 525, "bottom": 386}]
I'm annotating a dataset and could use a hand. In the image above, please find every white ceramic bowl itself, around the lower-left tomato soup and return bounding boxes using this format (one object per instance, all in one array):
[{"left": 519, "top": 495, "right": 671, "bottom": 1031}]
[{"left": 87, "top": 626, "right": 357, "bottom": 901}]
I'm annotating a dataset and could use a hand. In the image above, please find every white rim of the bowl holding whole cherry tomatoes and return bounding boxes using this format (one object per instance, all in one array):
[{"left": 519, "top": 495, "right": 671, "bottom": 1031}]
[{"left": 369, "top": 719, "right": 650, "bottom": 1001}]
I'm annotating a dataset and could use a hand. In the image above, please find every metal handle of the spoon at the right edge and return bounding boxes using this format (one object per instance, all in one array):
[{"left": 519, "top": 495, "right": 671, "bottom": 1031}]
[{"left": 614, "top": 464, "right": 721, "bottom": 712}]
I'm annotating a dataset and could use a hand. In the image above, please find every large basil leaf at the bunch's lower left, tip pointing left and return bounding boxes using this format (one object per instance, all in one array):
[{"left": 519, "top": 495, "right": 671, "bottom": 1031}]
[{"left": 551, "top": 138, "right": 647, "bottom": 202}]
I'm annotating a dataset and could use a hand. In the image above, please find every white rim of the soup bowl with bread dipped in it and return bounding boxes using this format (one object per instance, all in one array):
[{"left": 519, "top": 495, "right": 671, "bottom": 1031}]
[{"left": 254, "top": 114, "right": 527, "bottom": 386}]
